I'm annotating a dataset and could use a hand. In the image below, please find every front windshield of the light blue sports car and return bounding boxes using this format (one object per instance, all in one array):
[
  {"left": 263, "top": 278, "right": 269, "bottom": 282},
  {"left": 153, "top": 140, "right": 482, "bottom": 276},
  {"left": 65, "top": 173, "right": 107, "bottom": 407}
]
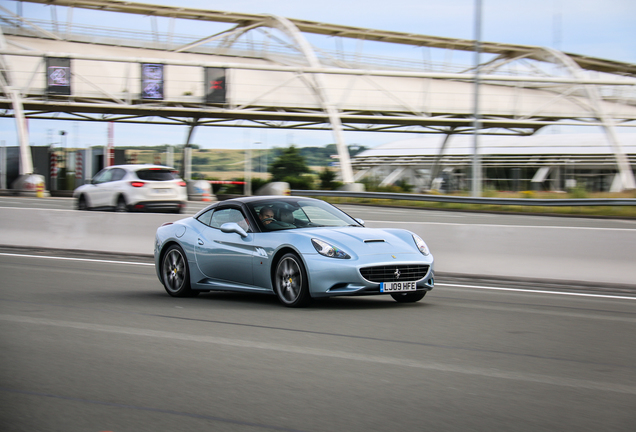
[{"left": 249, "top": 198, "right": 361, "bottom": 231}]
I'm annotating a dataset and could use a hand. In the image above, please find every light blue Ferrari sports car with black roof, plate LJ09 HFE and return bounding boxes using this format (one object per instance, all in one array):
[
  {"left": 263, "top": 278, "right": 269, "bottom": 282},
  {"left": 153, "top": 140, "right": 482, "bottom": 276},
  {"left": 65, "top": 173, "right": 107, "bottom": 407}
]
[{"left": 154, "top": 196, "right": 434, "bottom": 307}]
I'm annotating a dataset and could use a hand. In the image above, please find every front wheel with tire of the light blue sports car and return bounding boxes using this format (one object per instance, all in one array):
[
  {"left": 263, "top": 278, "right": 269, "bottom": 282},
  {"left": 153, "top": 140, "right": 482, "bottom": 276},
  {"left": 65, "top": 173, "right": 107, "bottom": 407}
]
[{"left": 274, "top": 253, "right": 311, "bottom": 307}]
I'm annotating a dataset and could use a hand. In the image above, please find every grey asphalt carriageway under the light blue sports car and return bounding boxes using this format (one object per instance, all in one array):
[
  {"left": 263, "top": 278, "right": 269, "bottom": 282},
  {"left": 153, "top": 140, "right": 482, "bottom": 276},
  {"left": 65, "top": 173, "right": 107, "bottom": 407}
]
[{"left": 0, "top": 249, "right": 636, "bottom": 432}]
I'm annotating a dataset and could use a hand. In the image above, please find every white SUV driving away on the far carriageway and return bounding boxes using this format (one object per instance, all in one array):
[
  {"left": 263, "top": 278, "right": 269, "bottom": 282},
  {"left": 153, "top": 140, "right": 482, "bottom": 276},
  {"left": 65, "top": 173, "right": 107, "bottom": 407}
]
[{"left": 73, "top": 165, "right": 188, "bottom": 213}]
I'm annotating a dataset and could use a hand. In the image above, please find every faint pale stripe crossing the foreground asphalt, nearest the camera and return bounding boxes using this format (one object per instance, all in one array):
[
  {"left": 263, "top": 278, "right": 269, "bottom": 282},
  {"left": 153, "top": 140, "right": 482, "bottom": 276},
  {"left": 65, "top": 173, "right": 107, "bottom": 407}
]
[{"left": 0, "top": 314, "right": 636, "bottom": 395}]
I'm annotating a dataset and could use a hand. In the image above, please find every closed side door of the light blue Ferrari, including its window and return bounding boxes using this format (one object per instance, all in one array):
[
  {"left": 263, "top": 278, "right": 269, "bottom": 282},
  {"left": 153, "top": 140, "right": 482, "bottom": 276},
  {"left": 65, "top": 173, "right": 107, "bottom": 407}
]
[{"left": 195, "top": 207, "right": 254, "bottom": 285}]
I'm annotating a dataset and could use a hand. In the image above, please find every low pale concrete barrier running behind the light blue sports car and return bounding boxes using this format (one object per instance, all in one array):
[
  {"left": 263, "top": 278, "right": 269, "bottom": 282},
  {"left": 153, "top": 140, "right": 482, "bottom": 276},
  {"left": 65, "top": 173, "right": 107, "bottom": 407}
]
[{"left": 0, "top": 208, "right": 636, "bottom": 286}]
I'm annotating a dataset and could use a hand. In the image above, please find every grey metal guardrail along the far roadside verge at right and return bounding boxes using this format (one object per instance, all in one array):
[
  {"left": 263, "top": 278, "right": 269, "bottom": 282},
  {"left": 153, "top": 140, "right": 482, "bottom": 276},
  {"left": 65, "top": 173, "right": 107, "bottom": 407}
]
[{"left": 291, "top": 189, "right": 636, "bottom": 207}]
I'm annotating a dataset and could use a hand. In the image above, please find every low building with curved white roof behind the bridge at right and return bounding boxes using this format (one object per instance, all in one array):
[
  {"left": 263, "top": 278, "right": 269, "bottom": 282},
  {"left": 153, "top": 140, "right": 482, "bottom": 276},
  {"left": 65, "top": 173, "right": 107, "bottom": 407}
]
[{"left": 352, "top": 134, "right": 636, "bottom": 192}]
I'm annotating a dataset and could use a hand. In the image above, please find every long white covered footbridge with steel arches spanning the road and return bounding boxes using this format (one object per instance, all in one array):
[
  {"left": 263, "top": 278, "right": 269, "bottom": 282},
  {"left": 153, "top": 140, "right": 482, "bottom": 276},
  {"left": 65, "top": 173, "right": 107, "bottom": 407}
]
[{"left": 0, "top": 0, "right": 636, "bottom": 189}]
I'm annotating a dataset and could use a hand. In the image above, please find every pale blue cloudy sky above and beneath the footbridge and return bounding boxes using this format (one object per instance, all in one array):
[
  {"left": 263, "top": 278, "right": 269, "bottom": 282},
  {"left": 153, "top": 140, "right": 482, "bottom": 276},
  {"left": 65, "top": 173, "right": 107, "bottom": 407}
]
[{"left": 0, "top": 0, "right": 636, "bottom": 148}]
